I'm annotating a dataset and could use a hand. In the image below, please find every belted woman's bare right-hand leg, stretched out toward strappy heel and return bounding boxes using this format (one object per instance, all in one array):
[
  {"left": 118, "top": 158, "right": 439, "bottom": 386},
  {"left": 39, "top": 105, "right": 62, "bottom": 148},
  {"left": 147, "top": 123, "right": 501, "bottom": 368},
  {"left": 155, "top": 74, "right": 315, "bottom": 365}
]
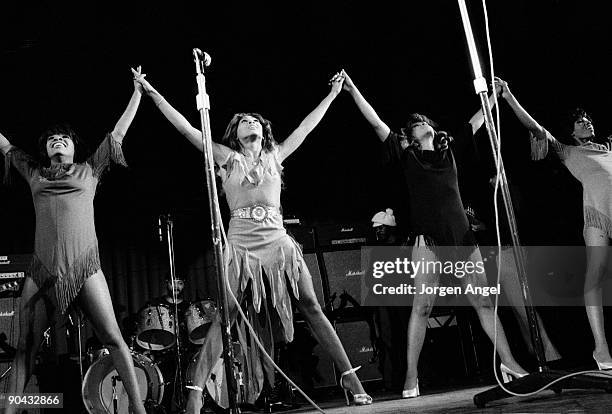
[{"left": 297, "top": 266, "right": 365, "bottom": 394}]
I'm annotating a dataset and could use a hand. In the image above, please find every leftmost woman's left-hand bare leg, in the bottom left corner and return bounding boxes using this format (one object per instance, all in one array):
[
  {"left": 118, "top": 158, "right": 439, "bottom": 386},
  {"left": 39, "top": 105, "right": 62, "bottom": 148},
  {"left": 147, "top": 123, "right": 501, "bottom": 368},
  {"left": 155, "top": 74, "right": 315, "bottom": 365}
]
[{"left": 5, "top": 277, "right": 54, "bottom": 413}]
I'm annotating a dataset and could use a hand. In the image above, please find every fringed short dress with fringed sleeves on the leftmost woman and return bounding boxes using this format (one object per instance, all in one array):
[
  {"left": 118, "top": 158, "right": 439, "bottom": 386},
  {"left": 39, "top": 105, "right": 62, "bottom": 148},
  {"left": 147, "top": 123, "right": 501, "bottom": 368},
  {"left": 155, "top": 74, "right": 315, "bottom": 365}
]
[{"left": 5, "top": 133, "right": 126, "bottom": 314}]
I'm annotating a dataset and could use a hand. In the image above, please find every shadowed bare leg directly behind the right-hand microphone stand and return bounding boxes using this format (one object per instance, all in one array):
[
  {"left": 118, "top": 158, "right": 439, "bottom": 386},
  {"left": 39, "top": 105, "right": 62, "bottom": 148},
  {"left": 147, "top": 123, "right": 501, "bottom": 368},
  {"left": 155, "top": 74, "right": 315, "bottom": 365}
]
[{"left": 498, "top": 248, "right": 561, "bottom": 361}]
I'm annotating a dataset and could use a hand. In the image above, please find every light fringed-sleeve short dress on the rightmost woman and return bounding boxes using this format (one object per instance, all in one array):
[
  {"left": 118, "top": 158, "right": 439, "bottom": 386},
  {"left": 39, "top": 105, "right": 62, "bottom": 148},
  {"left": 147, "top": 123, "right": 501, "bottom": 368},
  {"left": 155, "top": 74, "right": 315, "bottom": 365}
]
[{"left": 531, "top": 129, "right": 612, "bottom": 238}]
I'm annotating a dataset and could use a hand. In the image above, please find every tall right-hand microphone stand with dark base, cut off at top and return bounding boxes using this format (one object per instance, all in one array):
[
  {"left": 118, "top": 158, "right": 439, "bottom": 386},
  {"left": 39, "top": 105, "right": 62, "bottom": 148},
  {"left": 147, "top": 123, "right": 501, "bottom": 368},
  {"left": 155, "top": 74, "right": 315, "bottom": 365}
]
[{"left": 457, "top": 0, "right": 612, "bottom": 408}]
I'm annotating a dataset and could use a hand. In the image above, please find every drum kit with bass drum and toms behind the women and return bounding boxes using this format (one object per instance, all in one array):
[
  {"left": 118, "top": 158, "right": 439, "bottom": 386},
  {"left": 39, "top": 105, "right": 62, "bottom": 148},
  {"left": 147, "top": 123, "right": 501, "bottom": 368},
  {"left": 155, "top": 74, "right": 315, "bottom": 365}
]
[{"left": 82, "top": 300, "right": 218, "bottom": 414}]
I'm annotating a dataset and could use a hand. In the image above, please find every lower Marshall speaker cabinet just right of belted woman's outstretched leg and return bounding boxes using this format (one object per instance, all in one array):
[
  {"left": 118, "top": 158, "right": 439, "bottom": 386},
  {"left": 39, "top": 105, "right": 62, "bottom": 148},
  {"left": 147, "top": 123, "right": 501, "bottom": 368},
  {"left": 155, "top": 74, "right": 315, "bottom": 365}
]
[{"left": 336, "top": 320, "right": 383, "bottom": 382}]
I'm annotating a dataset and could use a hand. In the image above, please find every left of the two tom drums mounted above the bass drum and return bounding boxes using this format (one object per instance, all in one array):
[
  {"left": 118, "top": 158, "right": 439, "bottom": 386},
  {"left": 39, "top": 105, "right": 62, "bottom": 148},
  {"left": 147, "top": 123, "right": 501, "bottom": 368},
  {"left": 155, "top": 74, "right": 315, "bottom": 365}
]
[{"left": 136, "top": 304, "right": 176, "bottom": 351}]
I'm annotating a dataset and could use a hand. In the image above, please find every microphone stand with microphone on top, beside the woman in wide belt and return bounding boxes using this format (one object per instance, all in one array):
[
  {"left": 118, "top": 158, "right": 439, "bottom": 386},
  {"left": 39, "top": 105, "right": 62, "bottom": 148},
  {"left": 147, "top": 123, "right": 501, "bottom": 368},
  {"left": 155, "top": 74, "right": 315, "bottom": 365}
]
[{"left": 193, "top": 49, "right": 240, "bottom": 414}]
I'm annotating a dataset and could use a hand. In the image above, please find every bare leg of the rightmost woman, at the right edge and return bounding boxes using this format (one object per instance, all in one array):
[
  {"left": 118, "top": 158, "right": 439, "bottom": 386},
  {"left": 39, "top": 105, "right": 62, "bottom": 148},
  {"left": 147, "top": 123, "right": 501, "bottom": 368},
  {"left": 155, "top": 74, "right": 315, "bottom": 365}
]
[{"left": 584, "top": 227, "right": 612, "bottom": 363}]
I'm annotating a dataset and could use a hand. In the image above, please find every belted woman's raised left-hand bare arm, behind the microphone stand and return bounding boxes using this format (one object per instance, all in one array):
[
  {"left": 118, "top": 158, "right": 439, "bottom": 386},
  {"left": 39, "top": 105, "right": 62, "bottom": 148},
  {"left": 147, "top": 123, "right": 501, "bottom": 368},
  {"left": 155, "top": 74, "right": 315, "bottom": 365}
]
[{"left": 139, "top": 78, "right": 231, "bottom": 164}]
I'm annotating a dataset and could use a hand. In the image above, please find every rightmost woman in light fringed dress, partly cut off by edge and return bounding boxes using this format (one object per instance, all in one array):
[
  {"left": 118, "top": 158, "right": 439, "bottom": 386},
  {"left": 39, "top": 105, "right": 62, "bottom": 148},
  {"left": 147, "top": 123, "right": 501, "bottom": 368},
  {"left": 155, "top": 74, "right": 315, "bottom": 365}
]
[{"left": 496, "top": 78, "right": 612, "bottom": 369}]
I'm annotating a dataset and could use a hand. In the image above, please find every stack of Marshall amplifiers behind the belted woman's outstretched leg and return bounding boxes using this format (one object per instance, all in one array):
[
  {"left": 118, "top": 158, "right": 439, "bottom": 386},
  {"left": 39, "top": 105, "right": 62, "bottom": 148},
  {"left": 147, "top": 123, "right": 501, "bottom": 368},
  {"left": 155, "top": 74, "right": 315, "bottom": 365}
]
[{"left": 285, "top": 222, "right": 382, "bottom": 388}]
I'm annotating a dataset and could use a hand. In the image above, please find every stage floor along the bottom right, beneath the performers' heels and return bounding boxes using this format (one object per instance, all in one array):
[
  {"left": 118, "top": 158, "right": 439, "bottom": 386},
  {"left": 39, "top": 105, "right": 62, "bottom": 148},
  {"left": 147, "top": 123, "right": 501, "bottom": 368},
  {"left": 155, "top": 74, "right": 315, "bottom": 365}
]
[{"left": 284, "top": 386, "right": 612, "bottom": 414}]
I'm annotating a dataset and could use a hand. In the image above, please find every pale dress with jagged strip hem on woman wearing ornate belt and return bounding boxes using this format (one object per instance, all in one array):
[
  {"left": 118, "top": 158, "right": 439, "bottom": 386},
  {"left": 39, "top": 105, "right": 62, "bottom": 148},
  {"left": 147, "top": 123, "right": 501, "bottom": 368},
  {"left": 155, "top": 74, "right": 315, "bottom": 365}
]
[{"left": 216, "top": 148, "right": 311, "bottom": 402}]
